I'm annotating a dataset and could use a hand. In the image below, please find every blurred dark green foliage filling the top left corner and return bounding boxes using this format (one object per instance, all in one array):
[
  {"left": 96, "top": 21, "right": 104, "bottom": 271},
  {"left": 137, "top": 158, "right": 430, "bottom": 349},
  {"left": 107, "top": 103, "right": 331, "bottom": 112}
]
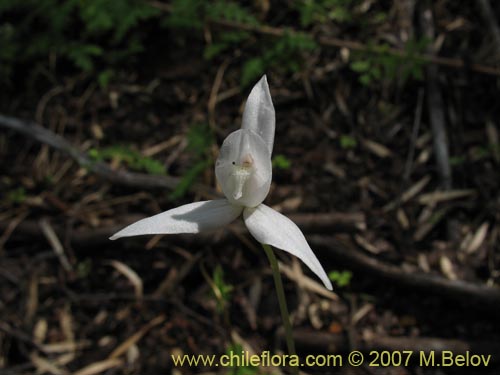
[{"left": 0, "top": 0, "right": 159, "bottom": 85}]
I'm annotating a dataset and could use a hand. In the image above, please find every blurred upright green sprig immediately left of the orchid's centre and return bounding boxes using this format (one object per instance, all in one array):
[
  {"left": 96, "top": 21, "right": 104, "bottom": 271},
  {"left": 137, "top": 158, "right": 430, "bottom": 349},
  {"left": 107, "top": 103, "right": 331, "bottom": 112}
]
[{"left": 169, "top": 124, "right": 215, "bottom": 199}]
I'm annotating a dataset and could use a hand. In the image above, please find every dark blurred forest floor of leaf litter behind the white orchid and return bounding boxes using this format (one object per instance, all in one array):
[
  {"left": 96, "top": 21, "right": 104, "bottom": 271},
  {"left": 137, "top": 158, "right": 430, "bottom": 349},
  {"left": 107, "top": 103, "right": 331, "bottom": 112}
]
[{"left": 0, "top": 0, "right": 500, "bottom": 375}]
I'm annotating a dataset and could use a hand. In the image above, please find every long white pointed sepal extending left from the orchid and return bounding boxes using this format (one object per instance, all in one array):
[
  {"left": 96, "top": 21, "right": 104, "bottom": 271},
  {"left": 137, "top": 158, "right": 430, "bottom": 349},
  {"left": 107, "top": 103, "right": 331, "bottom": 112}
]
[{"left": 110, "top": 199, "right": 242, "bottom": 240}]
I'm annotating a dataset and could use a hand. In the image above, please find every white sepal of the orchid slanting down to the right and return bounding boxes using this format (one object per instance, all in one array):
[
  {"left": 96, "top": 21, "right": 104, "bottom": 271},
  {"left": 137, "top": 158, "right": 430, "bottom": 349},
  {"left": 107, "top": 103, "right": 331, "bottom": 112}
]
[{"left": 243, "top": 204, "right": 332, "bottom": 290}]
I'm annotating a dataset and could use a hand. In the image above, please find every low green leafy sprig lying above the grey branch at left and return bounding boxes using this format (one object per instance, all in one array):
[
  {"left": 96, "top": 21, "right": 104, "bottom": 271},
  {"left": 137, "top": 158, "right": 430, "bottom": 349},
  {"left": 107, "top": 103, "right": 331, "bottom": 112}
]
[{"left": 89, "top": 146, "right": 165, "bottom": 175}]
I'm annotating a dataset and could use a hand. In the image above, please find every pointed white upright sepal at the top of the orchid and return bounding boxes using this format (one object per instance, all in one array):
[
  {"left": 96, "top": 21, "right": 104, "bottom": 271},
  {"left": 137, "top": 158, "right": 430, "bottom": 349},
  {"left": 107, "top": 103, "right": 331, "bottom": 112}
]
[{"left": 241, "top": 75, "right": 276, "bottom": 155}]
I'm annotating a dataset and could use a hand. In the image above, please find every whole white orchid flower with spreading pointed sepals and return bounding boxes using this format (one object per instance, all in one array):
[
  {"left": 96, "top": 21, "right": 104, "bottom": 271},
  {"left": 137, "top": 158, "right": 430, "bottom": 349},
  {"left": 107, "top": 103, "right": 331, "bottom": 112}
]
[{"left": 111, "top": 76, "right": 332, "bottom": 290}]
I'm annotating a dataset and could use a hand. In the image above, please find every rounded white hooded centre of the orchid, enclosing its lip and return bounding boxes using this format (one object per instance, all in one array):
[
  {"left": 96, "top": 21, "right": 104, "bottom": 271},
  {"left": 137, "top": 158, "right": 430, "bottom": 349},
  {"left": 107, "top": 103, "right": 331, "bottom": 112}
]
[{"left": 215, "top": 129, "right": 272, "bottom": 207}]
